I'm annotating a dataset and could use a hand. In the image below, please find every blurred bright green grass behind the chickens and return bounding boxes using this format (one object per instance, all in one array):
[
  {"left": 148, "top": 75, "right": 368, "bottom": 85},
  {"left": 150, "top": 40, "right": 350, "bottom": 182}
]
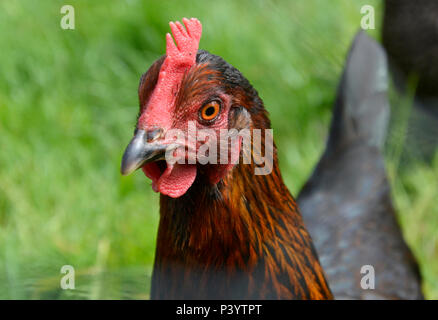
[{"left": 0, "top": 0, "right": 438, "bottom": 299}]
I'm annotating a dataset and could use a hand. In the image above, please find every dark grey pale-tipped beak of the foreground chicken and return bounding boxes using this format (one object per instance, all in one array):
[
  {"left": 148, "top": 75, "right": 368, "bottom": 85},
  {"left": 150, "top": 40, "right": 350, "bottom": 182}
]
[{"left": 120, "top": 130, "right": 167, "bottom": 176}]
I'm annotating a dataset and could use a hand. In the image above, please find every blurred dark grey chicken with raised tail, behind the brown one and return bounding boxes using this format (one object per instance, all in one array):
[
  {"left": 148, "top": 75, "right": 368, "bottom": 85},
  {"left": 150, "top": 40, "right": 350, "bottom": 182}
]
[{"left": 298, "top": 32, "right": 423, "bottom": 299}]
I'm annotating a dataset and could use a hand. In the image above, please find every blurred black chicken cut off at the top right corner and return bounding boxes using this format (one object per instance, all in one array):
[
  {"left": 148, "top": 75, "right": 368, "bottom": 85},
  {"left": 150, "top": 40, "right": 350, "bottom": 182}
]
[{"left": 382, "top": 0, "right": 438, "bottom": 163}]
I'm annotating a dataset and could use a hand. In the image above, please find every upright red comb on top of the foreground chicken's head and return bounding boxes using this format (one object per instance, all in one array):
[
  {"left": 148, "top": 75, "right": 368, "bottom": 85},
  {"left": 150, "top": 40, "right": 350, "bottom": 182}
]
[{"left": 138, "top": 18, "right": 202, "bottom": 129}]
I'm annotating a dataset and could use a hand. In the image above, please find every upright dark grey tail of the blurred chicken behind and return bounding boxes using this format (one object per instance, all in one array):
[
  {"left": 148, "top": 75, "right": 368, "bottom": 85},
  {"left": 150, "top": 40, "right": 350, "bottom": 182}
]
[{"left": 327, "top": 31, "right": 389, "bottom": 152}]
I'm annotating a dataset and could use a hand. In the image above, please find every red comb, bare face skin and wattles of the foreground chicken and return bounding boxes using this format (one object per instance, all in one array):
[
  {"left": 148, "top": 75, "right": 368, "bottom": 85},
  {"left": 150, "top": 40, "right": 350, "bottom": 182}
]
[{"left": 137, "top": 18, "right": 240, "bottom": 198}]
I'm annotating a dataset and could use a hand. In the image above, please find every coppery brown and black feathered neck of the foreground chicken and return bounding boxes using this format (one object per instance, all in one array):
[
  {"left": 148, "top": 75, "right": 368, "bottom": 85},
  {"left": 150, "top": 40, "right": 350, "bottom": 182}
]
[{"left": 151, "top": 155, "right": 331, "bottom": 299}]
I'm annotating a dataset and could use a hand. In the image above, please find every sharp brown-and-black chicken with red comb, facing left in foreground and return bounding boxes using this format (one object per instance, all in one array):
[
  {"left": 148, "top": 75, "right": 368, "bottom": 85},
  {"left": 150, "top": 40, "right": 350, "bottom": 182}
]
[{"left": 121, "top": 19, "right": 332, "bottom": 299}]
